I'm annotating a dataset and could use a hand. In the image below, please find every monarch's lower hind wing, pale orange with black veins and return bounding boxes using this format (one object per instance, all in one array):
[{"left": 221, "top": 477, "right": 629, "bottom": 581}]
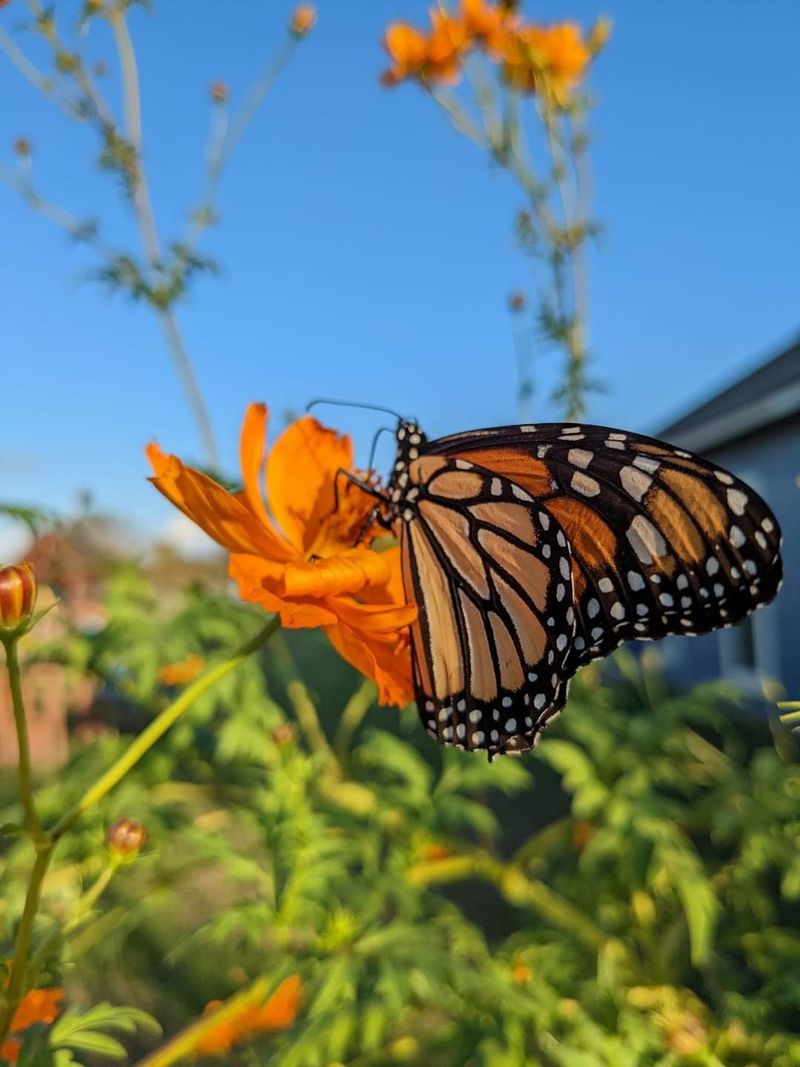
[{"left": 398, "top": 457, "right": 576, "bottom": 757}]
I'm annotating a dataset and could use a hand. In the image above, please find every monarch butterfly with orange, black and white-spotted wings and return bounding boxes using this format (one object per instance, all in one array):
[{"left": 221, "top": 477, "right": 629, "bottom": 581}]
[{"left": 379, "top": 418, "right": 782, "bottom": 760}]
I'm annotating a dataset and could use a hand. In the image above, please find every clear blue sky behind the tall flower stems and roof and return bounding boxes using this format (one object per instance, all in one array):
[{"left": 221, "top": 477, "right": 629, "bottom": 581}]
[{"left": 0, "top": 0, "right": 800, "bottom": 550}]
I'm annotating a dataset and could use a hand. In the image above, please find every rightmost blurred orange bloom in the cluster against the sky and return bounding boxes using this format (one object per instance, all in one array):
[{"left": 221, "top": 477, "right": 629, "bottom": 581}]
[{"left": 502, "top": 22, "right": 592, "bottom": 103}]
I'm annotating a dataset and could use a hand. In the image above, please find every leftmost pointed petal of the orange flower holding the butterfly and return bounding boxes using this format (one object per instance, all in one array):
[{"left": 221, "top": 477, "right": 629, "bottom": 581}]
[{"left": 147, "top": 444, "right": 293, "bottom": 560}]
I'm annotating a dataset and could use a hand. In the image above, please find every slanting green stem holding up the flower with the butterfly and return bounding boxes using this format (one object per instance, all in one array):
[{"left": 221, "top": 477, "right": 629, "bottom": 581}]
[{"left": 51, "top": 616, "right": 281, "bottom": 841}]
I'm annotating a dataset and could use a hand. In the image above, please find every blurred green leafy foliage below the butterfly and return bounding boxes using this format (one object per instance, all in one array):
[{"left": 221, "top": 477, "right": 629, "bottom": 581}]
[{"left": 0, "top": 562, "right": 800, "bottom": 1067}]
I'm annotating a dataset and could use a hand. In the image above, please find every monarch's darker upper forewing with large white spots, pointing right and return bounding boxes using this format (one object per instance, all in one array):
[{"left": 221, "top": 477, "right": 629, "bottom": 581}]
[{"left": 426, "top": 425, "right": 782, "bottom": 672}]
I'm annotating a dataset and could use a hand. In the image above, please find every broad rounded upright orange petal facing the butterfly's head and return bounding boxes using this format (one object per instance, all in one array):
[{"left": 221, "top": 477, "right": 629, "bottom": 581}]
[{"left": 267, "top": 415, "right": 353, "bottom": 555}]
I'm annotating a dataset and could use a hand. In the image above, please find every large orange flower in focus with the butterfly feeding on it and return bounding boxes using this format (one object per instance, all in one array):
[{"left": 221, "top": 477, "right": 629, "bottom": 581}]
[{"left": 147, "top": 404, "right": 416, "bottom": 706}]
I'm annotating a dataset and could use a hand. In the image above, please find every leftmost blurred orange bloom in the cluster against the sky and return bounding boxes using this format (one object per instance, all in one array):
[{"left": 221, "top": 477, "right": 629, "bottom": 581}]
[{"left": 381, "top": 10, "right": 469, "bottom": 86}]
